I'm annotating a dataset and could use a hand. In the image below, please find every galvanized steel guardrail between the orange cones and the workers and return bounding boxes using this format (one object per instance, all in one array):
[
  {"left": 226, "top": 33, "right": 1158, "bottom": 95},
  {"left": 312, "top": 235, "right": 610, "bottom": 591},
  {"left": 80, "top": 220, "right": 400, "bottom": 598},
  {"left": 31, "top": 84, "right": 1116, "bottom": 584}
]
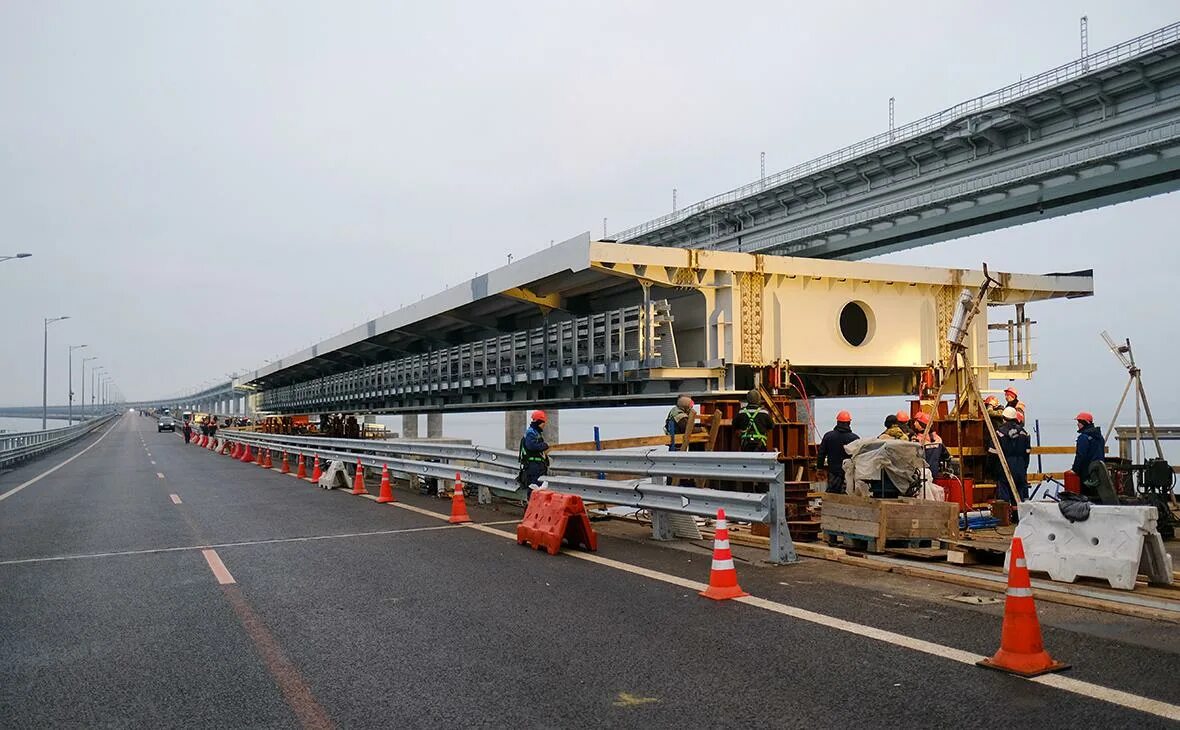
[{"left": 221, "top": 430, "right": 798, "bottom": 563}]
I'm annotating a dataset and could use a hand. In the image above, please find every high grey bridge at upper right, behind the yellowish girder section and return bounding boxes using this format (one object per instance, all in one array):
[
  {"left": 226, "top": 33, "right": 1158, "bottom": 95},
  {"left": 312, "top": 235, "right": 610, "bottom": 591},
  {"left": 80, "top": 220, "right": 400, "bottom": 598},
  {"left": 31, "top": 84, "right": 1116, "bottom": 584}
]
[{"left": 611, "top": 24, "right": 1180, "bottom": 259}]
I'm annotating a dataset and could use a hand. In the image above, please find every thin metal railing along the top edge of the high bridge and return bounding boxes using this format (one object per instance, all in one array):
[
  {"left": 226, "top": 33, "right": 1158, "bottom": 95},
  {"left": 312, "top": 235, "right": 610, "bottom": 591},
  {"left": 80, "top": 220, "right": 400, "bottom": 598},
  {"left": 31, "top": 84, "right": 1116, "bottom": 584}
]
[{"left": 612, "top": 22, "right": 1180, "bottom": 242}]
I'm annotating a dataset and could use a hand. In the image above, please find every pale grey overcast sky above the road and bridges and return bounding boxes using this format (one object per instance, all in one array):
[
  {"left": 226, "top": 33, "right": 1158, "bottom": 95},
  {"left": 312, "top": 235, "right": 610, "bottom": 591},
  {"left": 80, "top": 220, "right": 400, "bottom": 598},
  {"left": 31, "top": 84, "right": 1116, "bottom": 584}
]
[{"left": 0, "top": 0, "right": 1180, "bottom": 438}]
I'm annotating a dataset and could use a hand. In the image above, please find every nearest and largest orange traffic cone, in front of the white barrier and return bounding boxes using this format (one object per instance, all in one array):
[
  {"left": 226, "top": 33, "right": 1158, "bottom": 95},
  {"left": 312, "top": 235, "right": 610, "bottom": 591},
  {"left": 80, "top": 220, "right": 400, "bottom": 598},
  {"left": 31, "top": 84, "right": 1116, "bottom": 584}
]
[{"left": 977, "top": 538, "right": 1069, "bottom": 677}]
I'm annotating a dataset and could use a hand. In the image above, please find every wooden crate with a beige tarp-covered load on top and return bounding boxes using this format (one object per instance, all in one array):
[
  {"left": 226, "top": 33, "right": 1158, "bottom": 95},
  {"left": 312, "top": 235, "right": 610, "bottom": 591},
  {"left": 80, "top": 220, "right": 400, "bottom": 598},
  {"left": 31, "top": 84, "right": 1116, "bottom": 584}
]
[{"left": 820, "top": 494, "right": 959, "bottom": 553}]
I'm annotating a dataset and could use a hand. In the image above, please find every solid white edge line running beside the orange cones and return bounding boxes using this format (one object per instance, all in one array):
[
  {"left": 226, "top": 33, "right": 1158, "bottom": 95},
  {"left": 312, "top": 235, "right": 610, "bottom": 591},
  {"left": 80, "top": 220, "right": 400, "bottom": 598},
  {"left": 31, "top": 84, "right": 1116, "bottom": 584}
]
[{"left": 415, "top": 511, "right": 1180, "bottom": 721}]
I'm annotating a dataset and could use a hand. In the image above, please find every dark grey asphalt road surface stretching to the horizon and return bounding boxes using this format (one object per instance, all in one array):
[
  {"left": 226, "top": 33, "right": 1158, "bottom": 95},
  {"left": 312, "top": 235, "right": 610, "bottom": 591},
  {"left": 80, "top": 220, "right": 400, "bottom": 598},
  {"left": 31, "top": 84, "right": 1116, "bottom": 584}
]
[{"left": 0, "top": 416, "right": 1180, "bottom": 728}]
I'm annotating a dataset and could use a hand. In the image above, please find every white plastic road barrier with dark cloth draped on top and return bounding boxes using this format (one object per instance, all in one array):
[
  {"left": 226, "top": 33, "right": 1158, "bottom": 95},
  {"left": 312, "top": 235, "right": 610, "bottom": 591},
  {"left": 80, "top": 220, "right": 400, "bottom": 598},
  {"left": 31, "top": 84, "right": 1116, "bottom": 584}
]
[{"left": 1004, "top": 501, "right": 1172, "bottom": 591}]
